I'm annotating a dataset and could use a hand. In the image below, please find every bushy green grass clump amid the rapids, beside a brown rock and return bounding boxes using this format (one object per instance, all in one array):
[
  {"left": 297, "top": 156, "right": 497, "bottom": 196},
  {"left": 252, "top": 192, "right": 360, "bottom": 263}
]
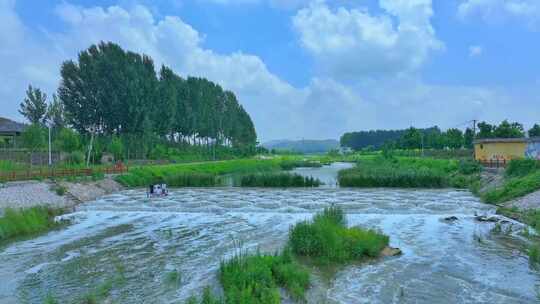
[{"left": 289, "top": 207, "right": 389, "bottom": 264}]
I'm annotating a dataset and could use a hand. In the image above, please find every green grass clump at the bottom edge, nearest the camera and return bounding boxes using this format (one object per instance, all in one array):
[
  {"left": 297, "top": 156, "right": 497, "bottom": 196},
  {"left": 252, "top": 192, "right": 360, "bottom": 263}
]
[{"left": 219, "top": 249, "right": 310, "bottom": 304}]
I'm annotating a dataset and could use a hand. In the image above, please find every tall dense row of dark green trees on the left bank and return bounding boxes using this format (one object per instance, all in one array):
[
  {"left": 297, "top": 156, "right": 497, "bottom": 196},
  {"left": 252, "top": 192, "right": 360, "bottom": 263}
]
[{"left": 20, "top": 42, "right": 257, "bottom": 163}]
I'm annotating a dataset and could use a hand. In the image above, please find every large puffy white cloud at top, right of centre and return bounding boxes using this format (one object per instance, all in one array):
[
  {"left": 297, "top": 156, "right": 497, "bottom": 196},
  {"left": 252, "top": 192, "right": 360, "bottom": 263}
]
[{"left": 293, "top": 0, "right": 444, "bottom": 79}]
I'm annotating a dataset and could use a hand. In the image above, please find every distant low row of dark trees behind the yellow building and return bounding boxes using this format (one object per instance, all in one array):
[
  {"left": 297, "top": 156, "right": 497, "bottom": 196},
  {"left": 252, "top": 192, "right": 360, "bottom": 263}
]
[{"left": 340, "top": 120, "right": 540, "bottom": 150}]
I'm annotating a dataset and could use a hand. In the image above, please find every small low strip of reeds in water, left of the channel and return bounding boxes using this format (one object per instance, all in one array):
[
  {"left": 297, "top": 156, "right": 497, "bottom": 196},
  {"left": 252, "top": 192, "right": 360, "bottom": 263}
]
[{"left": 240, "top": 173, "right": 322, "bottom": 187}]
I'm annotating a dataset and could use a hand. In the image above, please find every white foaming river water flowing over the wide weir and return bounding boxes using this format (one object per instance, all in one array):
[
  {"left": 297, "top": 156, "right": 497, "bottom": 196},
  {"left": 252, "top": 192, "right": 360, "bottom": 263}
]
[{"left": 0, "top": 164, "right": 540, "bottom": 303}]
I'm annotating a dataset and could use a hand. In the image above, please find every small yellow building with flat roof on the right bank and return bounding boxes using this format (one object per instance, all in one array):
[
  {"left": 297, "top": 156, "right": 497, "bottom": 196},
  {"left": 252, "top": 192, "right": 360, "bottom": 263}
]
[{"left": 474, "top": 138, "right": 529, "bottom": 162}]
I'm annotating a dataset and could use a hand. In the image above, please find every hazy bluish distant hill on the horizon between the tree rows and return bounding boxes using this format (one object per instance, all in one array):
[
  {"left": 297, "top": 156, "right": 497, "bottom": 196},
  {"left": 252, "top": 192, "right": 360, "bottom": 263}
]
[{"left": 262, "top": 139, "right": 339, "bottom": 153}]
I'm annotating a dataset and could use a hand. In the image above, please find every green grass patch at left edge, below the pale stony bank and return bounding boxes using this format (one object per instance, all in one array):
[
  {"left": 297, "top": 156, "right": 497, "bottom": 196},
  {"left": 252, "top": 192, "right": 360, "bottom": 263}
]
[{"left": 0, "top": 207, "right": 62, "bottom": 242}]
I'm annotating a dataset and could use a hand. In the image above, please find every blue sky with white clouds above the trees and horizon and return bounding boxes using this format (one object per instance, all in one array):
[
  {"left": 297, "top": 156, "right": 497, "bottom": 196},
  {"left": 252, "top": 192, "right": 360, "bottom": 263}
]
[{"left": 0, "top": 0, "right": 540, "bottom": 141}]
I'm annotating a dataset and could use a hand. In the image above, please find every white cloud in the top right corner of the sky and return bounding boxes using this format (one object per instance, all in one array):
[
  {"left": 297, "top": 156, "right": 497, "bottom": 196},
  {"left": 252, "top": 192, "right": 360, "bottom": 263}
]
[{"left": 458, "top": 0, "right": 540, "bottom": 27}]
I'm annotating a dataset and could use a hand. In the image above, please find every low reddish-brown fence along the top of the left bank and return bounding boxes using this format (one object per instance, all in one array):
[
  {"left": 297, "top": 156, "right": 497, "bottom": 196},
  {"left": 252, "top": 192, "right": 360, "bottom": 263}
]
[{"left": 0, "top": 165, "right": 129, "bottom": 182}]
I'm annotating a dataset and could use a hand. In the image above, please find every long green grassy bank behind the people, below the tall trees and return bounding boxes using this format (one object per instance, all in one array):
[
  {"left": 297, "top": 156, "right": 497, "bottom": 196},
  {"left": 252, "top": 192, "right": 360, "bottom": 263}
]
[{"left": 117, "top": 159, "right": 281, "bottom": 187}]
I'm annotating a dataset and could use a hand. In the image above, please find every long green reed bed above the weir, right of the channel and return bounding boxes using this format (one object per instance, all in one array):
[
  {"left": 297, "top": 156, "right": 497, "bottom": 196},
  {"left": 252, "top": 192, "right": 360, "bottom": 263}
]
[{"left": 338, "top": 157, "right": 480, "bottom": 188}]
